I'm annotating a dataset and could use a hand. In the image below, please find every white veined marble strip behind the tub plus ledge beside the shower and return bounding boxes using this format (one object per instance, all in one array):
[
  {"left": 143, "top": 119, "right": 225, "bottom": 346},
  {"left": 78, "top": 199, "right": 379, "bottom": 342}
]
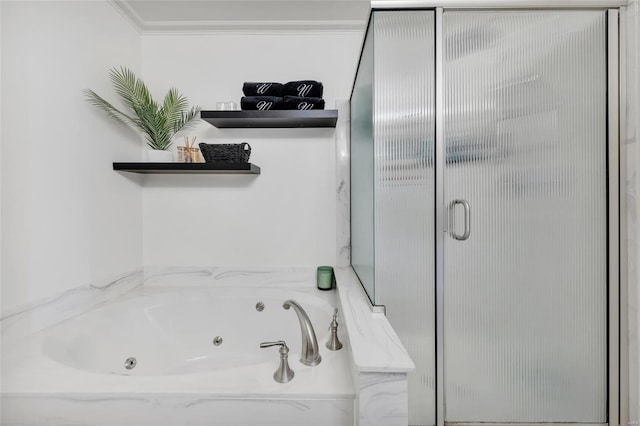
[{"left": 145, "top": 266, "right": 415, "bottom": 426}]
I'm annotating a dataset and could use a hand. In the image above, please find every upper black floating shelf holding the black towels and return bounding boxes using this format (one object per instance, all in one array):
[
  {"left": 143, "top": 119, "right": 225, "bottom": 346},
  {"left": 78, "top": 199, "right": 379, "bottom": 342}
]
[{"left": 200, "top": 109, "right": 338, "bottom": 129}]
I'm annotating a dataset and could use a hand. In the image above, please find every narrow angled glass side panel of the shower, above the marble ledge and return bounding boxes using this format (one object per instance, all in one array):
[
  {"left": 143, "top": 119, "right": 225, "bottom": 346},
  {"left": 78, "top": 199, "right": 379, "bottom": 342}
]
[{"left": 351, "top": 20, "right": 375, "bottom": 300}]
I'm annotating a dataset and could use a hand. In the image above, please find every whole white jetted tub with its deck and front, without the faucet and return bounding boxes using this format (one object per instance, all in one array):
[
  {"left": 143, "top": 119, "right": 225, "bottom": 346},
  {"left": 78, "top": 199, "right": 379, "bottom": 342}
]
[{"left": 2, "top": 285, "right": 354, "bottom": 426}]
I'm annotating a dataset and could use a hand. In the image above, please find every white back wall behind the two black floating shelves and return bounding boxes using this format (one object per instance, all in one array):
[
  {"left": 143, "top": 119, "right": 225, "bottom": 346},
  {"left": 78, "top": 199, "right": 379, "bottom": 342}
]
[{"left": 142, "top": 32, "right": 362, "bottom": 266}]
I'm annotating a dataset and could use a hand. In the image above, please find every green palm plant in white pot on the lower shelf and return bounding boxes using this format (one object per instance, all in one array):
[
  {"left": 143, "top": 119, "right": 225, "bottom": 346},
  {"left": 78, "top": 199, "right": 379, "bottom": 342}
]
[{"left": 84, "top": 67, "right": 201, "bottom": 161}]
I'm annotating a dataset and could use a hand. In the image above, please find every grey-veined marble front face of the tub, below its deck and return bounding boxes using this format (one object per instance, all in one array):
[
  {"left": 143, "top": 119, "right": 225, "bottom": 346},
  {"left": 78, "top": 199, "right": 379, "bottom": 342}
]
[{"left": 2, "top": 393, "right": 353, "bottom": 426}]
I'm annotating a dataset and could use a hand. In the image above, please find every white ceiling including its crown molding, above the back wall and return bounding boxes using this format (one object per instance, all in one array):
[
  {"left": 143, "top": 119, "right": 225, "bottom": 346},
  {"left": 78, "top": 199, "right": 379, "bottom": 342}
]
[{"left": 111, "top": 0, "right": 370, "bottom": 32}]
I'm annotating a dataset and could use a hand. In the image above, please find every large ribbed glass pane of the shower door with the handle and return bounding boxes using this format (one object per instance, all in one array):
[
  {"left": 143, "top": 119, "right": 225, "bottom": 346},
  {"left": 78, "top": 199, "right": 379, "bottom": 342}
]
[{"left": 443, "top": 11, "right": 607, "bottom": 423}]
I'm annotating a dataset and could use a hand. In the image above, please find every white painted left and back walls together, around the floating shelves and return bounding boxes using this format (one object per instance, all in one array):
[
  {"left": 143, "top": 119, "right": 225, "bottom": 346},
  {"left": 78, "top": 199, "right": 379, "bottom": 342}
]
[{"left": 0, "top": 1, "right": 362, "bottom": 312}]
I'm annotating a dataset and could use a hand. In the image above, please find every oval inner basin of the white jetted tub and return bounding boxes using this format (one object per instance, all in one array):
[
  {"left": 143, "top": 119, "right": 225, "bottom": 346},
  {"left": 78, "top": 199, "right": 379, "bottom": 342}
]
[{"left": 43, "top": 288, "right": 333, "bottom": 376}]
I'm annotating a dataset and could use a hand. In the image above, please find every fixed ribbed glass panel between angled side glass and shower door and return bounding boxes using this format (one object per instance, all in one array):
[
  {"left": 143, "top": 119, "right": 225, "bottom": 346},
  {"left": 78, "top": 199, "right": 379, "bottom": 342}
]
[{"left": 374, "top": 11, "right": 435, "bottom": 425}]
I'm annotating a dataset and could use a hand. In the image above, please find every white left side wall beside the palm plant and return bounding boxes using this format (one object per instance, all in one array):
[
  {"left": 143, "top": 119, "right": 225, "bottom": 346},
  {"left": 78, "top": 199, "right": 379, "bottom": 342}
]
[{"left": 0, "top": 1, "right": 142, "bottom": 312}]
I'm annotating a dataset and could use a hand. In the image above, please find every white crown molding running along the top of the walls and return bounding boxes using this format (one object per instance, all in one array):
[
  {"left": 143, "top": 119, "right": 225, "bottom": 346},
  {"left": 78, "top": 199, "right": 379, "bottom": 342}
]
[{"left": 108, "top": 0, "right": 367, "bottom": 35}]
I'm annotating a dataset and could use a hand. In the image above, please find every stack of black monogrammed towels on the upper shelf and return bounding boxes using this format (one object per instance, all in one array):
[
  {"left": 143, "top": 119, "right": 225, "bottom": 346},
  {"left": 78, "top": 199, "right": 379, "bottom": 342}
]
[{"left": 240, "top": 80, "right": 324, "bottom": 111}]
